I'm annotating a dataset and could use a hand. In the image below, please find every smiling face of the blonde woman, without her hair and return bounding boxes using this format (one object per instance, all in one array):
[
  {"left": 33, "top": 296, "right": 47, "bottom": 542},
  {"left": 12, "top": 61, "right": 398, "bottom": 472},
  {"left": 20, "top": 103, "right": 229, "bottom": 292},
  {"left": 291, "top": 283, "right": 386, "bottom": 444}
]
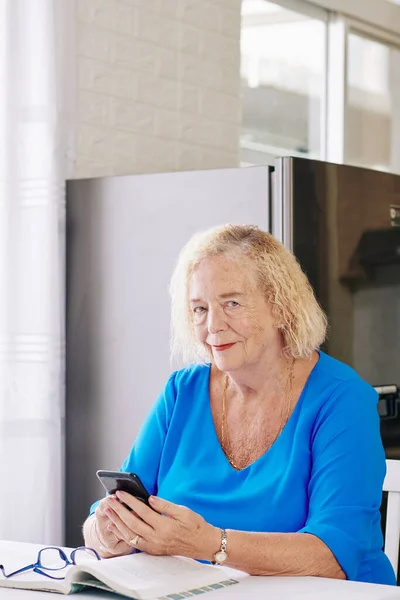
[{"left": 189, "top": 255, "right": 283, "bottom": 372}]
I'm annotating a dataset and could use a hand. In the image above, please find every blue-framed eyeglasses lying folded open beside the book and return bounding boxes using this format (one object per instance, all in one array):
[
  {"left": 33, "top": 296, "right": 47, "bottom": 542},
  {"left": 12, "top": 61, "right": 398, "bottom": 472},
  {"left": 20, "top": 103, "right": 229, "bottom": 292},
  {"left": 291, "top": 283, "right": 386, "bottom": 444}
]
[{"left": 0, "top": 546, "right": 101, "bottom": 579}]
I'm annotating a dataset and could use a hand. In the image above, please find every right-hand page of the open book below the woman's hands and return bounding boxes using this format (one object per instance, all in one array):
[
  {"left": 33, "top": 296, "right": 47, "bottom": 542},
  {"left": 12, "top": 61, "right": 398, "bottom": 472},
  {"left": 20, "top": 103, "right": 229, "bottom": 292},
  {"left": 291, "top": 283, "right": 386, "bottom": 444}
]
[{"left": 73, "top": 553, "right": 236, "bottom": 600}]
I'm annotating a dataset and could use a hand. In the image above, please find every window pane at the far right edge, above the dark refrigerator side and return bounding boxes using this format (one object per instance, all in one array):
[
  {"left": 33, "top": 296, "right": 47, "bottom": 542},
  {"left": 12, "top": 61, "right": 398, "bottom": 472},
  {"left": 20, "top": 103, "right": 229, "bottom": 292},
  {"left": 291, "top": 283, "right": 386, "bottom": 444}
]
[{"left": 345, "top": 33, "right": 400, "bottom": 172}]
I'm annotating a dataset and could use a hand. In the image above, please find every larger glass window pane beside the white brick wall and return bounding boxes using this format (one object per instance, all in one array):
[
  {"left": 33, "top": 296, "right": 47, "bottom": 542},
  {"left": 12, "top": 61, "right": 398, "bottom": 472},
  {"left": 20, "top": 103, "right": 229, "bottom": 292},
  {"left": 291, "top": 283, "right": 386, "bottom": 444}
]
[{"left": 241, "top": 0, "right": 327, "bottom": 162}]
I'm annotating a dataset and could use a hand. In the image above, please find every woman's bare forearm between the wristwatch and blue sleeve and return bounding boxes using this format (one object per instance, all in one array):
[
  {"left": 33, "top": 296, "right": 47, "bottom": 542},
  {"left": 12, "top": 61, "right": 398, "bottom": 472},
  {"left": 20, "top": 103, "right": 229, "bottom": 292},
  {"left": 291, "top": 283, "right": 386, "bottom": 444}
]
[{"left": 217, "top": 529, "right": 346, "bottom": 579}]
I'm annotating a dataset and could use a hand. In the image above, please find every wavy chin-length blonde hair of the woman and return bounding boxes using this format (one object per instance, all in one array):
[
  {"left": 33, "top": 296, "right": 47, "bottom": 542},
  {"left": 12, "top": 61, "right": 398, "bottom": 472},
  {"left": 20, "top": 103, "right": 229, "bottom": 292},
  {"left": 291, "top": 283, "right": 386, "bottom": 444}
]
[{"left": 170, "top": 224, "right": 327, "bottom": 364}]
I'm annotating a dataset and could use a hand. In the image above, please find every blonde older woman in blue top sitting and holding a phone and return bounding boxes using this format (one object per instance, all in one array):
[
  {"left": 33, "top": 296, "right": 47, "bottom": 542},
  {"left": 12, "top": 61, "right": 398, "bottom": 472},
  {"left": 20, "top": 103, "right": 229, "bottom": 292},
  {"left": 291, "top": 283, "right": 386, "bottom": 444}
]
[{"left": 84, "top": 225, "right": 395, "bottom": 584}]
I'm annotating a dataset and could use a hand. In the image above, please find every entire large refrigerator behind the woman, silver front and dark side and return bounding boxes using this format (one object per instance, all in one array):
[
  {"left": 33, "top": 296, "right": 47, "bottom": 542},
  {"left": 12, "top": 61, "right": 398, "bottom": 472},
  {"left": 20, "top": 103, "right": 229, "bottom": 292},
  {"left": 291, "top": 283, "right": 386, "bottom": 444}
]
[{"left": 66, "top": 158, "right": 400, "bottom": 545}]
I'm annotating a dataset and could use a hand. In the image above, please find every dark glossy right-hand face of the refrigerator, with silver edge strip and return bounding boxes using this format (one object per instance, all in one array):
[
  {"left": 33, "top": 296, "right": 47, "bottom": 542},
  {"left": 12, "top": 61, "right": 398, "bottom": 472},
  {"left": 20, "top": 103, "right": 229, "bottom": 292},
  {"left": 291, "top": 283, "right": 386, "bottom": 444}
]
[{"left": 272, "top": 158, "right": 400, "bottom": 382}]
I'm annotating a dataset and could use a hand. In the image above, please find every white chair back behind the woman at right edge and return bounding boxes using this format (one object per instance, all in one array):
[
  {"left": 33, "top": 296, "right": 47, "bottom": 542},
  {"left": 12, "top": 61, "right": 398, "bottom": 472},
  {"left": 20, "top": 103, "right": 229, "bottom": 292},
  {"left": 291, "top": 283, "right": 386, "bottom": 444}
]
[{"left": 383, "top": 459, "right": 400, "bottom": 577}]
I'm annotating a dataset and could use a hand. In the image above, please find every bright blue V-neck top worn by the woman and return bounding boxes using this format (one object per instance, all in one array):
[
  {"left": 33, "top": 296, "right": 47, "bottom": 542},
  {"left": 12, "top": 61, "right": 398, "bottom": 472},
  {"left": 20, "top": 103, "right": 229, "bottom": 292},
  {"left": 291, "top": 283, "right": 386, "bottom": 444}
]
[{"left": 91, "top": 352, "right": 396, "bottom": 585}]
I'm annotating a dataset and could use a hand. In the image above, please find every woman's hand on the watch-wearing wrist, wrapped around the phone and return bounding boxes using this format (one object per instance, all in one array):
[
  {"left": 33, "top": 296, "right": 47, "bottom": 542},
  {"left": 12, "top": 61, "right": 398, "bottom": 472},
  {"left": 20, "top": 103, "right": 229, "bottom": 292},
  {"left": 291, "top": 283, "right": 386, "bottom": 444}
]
[{"left": 105, "top": 491, "right": 221, "bottom": 561}]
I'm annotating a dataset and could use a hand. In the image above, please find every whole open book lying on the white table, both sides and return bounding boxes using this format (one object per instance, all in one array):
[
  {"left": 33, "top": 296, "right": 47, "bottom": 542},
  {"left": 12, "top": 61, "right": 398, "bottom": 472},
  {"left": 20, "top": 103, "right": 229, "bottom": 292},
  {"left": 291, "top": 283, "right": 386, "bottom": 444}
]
[{"left": 0, "top": 553, "right": 239, "bottom": 600}]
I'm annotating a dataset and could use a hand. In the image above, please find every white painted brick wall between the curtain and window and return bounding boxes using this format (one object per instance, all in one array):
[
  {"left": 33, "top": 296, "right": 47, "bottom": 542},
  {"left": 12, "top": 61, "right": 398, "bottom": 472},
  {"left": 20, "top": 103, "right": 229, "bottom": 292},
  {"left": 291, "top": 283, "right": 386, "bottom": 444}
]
[{"left": 76, "top": 0, "right": 241, "bottom": 177}]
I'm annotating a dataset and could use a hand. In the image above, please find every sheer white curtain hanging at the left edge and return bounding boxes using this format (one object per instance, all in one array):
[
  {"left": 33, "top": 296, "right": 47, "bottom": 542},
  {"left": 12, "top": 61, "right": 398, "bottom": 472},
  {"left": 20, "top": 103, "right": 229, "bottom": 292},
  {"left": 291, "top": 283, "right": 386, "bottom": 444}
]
[{"left": 0, "top": 0, "right": 76, "bottom": 544}]
